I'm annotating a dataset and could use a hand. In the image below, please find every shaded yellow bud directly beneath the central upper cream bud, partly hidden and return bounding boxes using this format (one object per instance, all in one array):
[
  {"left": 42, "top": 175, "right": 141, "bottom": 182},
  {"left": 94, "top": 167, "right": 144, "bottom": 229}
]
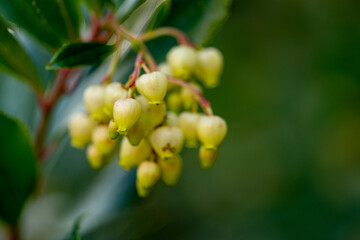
[{"left": 136, "top": 96, "right": 166, "bottom": 130}]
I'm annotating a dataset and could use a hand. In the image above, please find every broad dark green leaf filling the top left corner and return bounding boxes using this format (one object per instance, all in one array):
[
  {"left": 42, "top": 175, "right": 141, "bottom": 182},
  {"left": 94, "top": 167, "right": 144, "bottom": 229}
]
[{"left": 0, "top": 0, "right": 81, "bottom": 49}]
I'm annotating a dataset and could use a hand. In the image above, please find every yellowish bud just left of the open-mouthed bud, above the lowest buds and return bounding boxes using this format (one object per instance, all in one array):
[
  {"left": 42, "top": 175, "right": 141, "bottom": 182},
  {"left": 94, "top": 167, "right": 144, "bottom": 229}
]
[{"left": 119, "top": 137, "right": 152, "bottom": 170}]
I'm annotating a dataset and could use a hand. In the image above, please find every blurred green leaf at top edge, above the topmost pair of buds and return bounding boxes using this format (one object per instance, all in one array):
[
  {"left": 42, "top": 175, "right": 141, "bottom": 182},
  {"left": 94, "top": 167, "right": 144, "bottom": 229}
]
[{"left": 163, "top": 0, "right": 231, "bottom": 45}]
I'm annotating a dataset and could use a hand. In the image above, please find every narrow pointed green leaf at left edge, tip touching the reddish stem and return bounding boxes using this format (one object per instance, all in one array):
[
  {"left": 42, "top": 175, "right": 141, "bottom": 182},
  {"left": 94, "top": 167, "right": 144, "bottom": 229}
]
[{"left": 0, "top": 19, "right": 41, "bottom": 89}]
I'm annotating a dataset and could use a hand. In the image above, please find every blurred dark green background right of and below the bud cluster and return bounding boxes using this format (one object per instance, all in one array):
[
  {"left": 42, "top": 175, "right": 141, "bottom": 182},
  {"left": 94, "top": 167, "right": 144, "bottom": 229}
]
[{"left": 1, "top": 0, "right": 360, "bottom": 240}]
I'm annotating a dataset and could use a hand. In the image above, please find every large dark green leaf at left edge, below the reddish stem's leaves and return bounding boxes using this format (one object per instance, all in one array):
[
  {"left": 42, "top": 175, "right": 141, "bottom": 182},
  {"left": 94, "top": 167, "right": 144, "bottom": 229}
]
[{"left": 0, "top": 112, "right": 36, "bottom": 224}]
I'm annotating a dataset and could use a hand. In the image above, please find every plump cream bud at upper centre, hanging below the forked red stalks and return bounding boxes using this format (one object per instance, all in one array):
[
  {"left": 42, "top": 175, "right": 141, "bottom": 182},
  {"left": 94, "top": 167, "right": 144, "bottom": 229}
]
[{"left": 135, "top": 72, "right": 167, "bottom": 104}]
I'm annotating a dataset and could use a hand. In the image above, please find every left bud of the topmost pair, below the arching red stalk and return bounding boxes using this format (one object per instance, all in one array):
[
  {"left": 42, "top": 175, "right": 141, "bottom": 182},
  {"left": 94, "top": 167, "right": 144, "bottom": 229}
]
[{"left": 166, "top": 45, "right": 197, "bottom": 79}]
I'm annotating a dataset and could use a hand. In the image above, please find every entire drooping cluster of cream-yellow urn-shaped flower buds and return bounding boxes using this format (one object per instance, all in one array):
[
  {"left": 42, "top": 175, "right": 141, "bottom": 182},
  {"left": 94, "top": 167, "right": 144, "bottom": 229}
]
[{"left": 69, "top": 45, "right": 227, "bottom": 197}]
